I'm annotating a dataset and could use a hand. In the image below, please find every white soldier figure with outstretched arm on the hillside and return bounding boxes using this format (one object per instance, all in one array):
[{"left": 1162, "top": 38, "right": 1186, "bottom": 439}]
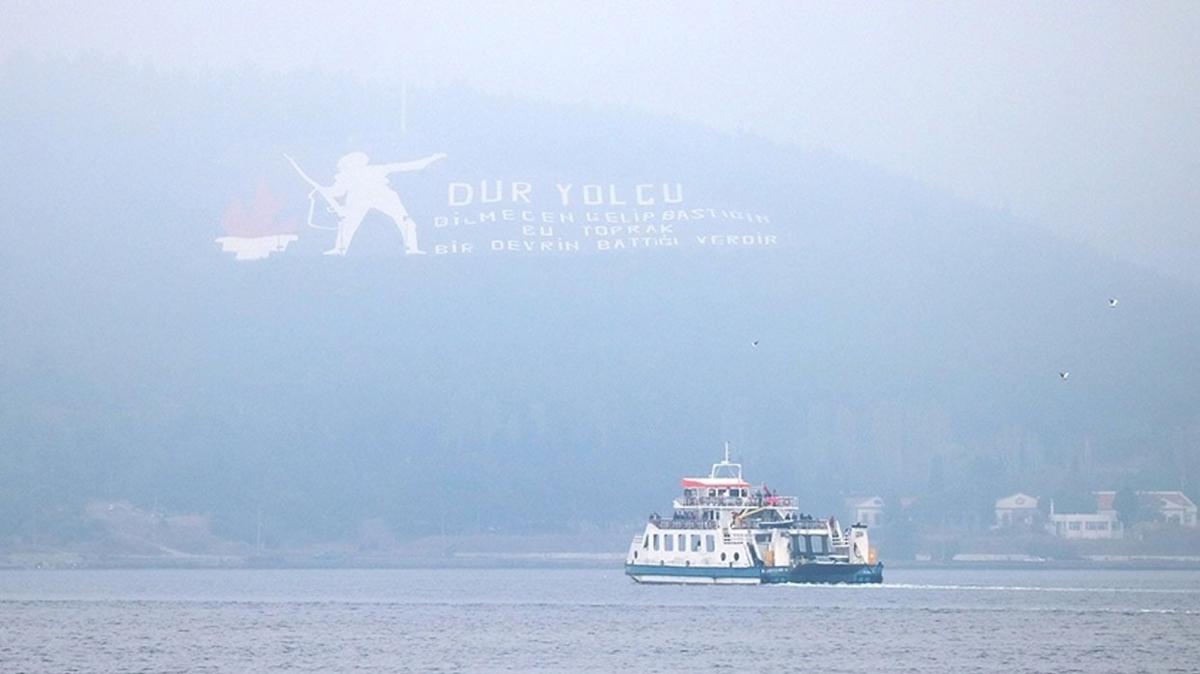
[{"left": 288, "top": 152, "right": 445, "bottom": 255}]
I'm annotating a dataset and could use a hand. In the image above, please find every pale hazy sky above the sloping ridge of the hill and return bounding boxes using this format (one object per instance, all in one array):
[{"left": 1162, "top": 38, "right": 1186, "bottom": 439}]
[{"left": 9, "top": 0, "right": 1200, "bottom": 283}]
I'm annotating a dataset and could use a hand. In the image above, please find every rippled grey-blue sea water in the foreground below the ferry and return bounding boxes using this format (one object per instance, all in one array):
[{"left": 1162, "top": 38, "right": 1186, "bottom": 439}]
[{"left": 0, "top": 570, "right": 1200, "bottom": 673}]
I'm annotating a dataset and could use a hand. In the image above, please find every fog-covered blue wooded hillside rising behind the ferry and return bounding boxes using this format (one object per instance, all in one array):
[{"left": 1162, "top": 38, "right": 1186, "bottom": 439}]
[{"left": 0, "top": 59, "right": 1200, "bottom": 543}]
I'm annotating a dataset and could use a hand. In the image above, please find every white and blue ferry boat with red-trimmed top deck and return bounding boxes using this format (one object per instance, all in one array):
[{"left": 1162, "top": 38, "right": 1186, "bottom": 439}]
[{"left": 625, "top": 443, "right": 883, "bottom": 585}]
